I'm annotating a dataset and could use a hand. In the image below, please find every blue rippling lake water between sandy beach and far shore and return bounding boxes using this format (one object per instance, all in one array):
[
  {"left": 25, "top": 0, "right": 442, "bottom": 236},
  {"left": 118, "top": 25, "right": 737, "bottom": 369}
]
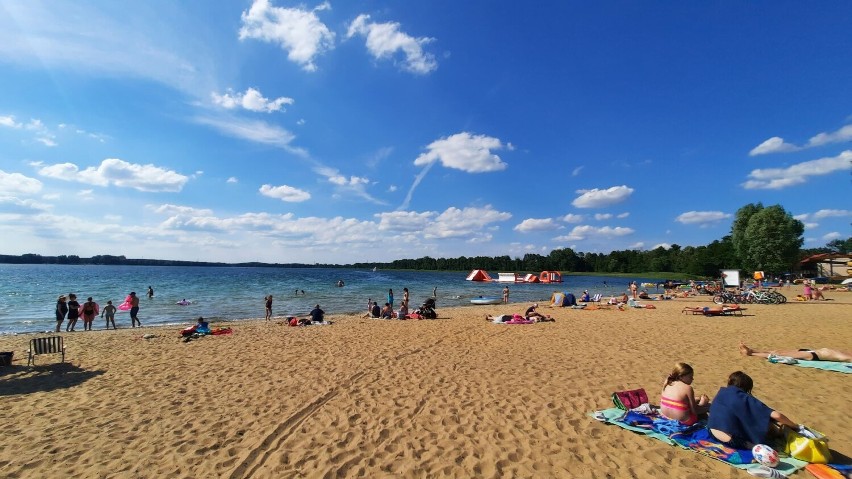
[{"left": 0, "top": 264, "right": 654, "bottom": 334}]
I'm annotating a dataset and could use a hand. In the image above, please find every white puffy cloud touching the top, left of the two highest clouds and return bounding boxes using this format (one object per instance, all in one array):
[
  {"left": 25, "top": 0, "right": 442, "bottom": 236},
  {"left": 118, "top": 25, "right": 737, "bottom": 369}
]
[{"left": 240, "top": 0, "right": 334, "bottom": 71}]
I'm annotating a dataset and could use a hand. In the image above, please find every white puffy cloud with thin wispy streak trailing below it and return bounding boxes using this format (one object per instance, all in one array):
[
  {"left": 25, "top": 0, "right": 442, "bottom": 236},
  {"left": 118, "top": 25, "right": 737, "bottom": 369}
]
[{"left": 414, "top": 132, "right": 507, "bottom": 173}]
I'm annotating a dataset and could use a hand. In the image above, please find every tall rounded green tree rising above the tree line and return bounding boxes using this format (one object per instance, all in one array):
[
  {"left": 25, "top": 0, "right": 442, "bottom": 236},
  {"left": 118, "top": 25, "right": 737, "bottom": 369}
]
[{"left": 731, "top": 203, "right": 805, "bottom": 273}]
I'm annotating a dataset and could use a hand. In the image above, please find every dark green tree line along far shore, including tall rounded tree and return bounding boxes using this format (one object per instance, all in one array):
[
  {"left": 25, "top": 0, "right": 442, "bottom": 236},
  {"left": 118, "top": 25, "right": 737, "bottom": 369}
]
[{"left": 0, "top": 203, "right": 852, "bottom": 277}]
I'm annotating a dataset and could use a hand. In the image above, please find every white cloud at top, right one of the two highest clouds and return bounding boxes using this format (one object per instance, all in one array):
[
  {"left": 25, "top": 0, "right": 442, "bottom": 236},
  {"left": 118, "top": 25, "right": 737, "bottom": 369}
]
[{"left": 346, "top": 14, "right": 438, "bottom": 75}]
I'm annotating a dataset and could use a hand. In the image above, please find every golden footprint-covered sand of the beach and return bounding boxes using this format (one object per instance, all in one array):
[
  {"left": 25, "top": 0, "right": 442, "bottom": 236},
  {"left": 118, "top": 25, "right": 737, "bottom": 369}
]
[{"left": 0, "top": 291, "right": 852, "bottom": 479}]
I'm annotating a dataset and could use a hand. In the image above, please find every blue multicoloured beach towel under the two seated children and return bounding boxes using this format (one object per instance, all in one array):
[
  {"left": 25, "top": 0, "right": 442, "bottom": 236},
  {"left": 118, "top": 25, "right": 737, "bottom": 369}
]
[{"left": 592, "top": 408, "right": 807, "bottom": 476}]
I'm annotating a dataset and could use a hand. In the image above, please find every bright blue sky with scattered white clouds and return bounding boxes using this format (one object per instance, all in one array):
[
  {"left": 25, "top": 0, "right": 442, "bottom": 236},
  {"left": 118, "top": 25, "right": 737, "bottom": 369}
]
[{"left": 0, "top": 0, "right": 852, "bottom": 263}]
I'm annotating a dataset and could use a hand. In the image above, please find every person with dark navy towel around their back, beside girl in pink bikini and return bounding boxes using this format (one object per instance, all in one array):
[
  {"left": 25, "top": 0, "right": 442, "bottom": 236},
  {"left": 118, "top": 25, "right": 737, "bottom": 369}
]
[{"left": 707, "top": 371, "right": 799, "bottom": 449}]
